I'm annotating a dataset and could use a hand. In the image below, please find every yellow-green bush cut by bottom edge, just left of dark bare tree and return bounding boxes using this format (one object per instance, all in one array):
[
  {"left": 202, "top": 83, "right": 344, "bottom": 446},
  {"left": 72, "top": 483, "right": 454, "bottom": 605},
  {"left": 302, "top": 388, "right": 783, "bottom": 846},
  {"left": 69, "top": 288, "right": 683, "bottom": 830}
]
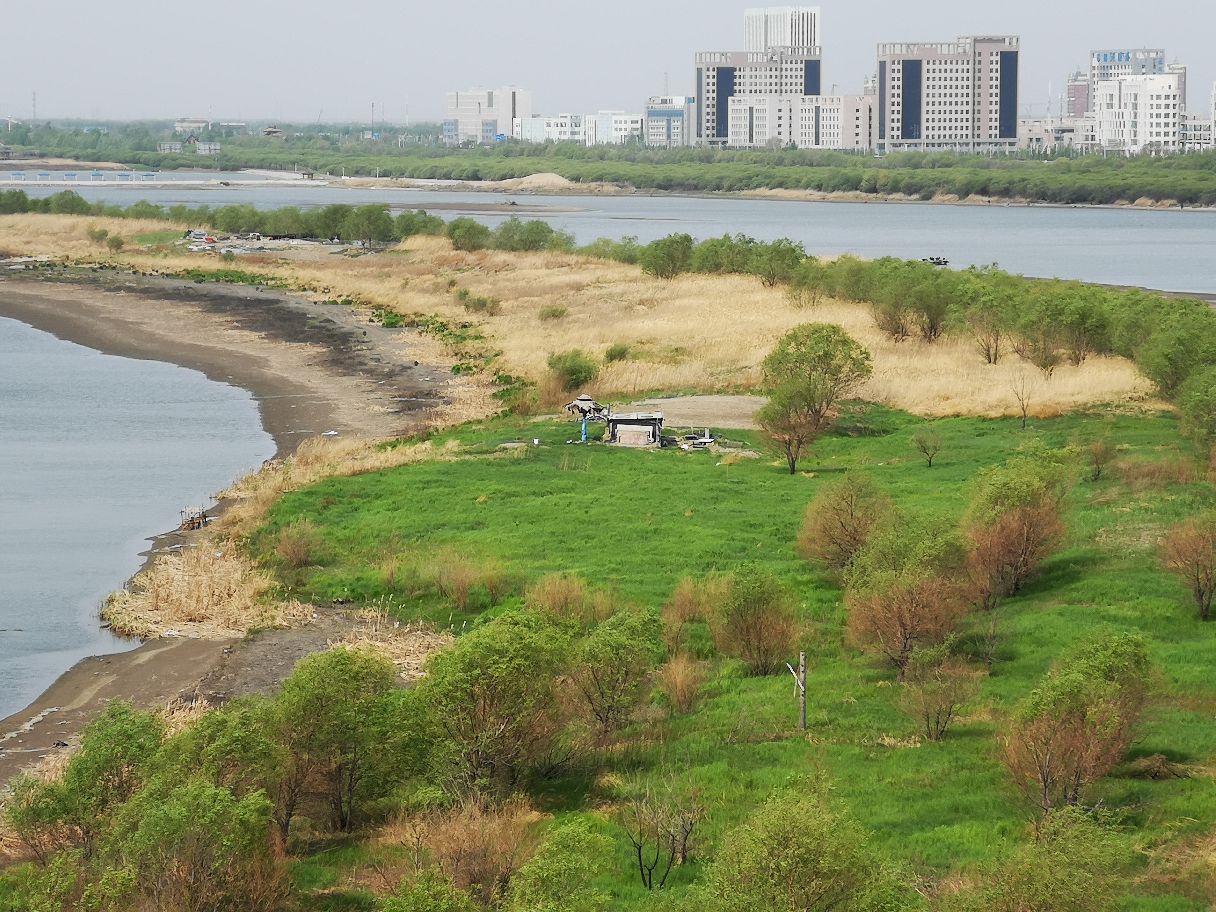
[{"left": 502, "top": 818, "right": 612, "bottom": 912}]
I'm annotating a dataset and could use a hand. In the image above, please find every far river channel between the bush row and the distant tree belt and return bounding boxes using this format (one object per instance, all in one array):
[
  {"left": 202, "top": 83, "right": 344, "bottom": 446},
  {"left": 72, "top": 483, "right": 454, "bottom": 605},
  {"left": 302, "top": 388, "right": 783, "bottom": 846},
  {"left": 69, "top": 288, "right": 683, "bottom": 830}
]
[{"left": 14, "top": 173, "right": 1216, "bottom": 292}]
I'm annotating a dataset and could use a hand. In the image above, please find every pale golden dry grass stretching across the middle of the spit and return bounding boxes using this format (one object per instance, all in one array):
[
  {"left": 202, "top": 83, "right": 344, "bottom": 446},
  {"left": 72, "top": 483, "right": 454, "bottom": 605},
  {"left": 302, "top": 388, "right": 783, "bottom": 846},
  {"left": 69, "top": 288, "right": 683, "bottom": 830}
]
[{"left": 0, "top": 215, "right": 1152, "bottom": 417}]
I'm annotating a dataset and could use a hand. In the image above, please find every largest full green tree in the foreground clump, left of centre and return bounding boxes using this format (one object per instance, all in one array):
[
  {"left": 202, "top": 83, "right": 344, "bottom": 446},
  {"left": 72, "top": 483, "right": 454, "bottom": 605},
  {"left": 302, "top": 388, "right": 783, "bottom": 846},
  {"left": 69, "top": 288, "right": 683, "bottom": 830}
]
[{"left": 416, "top": 612, "right": 567, "bottom": 794}]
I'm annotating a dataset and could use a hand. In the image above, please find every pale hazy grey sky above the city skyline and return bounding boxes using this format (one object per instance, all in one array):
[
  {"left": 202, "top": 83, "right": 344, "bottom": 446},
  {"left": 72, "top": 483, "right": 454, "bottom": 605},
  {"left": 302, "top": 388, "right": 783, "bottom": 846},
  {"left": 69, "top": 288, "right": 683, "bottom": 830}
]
[{"left": 0, "top": 0, "right": 1216, "bottom": 122}]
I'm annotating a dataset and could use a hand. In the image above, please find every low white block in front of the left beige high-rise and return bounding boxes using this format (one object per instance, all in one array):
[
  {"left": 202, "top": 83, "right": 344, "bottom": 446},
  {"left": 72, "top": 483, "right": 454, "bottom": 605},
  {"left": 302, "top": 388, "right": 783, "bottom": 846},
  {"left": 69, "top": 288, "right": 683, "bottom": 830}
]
[{"left": 727, "top": 95, "right": 877, "bottom": 152}]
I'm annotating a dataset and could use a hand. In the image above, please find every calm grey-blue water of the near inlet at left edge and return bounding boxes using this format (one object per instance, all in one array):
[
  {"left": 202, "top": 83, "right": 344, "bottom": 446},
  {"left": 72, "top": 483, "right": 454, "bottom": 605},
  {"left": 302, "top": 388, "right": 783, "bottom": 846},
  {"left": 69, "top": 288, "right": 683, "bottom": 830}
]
[{"left": 0, "top": 318, "right": 275, "bottom": 734}]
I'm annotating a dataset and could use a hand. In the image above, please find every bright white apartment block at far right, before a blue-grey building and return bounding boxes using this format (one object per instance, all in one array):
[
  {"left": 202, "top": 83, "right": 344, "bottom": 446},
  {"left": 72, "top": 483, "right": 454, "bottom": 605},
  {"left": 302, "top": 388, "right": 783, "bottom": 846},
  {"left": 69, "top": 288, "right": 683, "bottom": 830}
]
[{"left": 1079, "top": 74, "right": 1184, "bottom": 156}]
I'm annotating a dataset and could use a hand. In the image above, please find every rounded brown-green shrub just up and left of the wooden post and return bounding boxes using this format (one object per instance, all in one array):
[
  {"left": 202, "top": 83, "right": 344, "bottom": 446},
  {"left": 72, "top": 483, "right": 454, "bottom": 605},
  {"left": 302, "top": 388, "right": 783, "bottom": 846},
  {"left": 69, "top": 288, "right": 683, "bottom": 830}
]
[{"left": 713, "top": 564, "right": 796, "bottom": 675}]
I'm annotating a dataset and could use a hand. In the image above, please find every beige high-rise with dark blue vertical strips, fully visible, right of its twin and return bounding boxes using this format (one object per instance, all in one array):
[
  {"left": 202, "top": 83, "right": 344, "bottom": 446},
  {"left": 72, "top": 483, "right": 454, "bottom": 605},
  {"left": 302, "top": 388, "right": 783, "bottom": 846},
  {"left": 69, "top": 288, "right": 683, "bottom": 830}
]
[{"left": 877, "top": 35, "right": 1020, "bottom": 153}]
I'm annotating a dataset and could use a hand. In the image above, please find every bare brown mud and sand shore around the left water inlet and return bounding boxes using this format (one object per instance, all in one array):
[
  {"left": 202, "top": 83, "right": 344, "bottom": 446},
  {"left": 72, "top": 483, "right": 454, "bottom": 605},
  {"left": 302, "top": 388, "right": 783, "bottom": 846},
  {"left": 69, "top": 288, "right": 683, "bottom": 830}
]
[{"left": 0, "top": 271, "right": 451, "bottom": 783}]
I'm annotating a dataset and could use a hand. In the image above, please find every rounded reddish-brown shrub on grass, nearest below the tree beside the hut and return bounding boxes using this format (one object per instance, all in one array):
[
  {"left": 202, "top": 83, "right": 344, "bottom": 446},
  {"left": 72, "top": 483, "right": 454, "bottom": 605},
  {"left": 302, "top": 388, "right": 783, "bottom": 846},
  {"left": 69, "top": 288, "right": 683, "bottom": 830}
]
[{"left": 798, "top": 472, "right": 891, "bottom": 572}]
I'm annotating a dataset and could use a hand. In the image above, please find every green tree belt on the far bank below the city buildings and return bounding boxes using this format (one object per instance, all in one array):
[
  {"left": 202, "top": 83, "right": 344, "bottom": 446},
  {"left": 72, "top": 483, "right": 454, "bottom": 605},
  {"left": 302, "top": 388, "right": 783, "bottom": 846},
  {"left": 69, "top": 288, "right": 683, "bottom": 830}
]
[{"left": 13, "top": 120, "right": 1216, "bottom": 206}]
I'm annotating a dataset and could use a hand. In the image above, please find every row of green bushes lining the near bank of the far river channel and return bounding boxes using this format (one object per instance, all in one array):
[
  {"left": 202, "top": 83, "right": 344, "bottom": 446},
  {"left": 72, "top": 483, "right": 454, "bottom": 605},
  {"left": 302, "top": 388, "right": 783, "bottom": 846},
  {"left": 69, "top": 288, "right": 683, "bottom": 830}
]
[{"left": 7, "top": 190, "right": 1216, "bottom": 443}]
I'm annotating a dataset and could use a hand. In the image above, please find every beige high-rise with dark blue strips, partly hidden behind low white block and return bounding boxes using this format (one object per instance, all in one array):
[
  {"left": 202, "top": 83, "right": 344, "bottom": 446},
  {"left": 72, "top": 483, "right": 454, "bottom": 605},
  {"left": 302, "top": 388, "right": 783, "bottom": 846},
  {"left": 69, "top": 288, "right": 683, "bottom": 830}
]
[{"left": 696, "top": 47, "right": 821, "bottom": 145}]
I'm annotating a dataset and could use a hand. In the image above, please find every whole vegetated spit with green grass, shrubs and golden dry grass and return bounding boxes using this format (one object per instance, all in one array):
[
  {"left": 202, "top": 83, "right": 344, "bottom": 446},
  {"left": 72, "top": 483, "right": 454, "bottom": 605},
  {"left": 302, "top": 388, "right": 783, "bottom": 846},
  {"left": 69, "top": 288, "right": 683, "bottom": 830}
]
[{"left": 0, "top": 201, "right": 1216, "bottom": 912}]
